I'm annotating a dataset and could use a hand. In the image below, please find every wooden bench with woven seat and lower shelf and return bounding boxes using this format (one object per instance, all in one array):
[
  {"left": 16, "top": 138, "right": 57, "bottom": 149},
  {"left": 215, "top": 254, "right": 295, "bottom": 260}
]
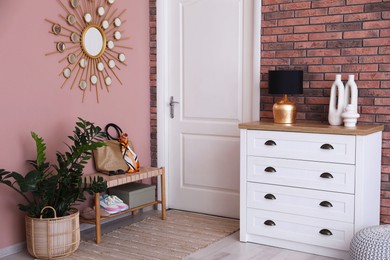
[{"left": 80, "top": 167, "right": 166, "bottom": 244}]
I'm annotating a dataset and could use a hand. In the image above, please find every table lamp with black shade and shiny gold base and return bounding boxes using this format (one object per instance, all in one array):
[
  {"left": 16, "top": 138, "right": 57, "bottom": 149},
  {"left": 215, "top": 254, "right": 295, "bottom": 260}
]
[{"left": 268, "top": 70, "right": 303, "bottom": 124}]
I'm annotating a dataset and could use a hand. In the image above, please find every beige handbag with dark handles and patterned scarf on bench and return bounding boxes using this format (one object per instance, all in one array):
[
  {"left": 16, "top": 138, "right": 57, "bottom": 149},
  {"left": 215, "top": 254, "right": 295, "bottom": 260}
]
[{"left": 93, "top": 123, "right": 139, "bottom": 175}]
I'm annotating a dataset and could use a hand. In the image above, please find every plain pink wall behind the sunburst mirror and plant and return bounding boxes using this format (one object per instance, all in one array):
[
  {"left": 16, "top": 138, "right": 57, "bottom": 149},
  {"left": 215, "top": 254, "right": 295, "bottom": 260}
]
[{"left": 0, "top": 0, "right": 150, "bottom": 249}]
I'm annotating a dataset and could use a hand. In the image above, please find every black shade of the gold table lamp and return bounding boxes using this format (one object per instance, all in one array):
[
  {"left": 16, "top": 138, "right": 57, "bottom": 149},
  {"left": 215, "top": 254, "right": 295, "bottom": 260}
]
[{"left": 268, "top": 70, "right": 303, "bottom": 94}]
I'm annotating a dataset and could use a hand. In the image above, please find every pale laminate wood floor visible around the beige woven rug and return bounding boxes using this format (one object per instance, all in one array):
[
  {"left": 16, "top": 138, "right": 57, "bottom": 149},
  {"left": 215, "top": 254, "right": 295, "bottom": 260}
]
[{"left": 1, "top": 210, "right": 333, "bottom": 260}]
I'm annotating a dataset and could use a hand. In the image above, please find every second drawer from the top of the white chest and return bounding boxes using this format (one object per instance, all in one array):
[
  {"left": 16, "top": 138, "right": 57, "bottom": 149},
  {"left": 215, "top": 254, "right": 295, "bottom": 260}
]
[{"left": 247, "top": 156, "right": 355, "bottom": 194}]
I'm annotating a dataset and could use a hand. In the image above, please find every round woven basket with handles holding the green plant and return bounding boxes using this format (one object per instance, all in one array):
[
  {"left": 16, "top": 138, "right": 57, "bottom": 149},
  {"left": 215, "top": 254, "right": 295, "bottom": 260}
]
[{"left": 25, "top": 206, "right": 80, "bottom": 259}]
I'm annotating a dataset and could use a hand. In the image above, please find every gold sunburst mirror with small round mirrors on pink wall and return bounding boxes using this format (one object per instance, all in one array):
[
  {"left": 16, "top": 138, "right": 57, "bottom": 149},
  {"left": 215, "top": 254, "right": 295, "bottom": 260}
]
[{"left": 45, "top": 0, "right": 131, "bottom": 103}]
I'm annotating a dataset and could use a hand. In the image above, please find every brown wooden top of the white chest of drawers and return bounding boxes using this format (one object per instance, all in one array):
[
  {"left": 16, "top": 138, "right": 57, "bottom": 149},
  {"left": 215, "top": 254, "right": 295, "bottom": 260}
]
[{"left": 238, "top": 121, "right": 384, "bottom": 135}]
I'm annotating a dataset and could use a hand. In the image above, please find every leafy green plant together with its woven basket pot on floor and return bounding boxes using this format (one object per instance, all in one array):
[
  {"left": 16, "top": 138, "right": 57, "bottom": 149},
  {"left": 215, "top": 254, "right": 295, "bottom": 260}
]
[{"left": 0, "top": 118, "right": 107, "bottom": 259}]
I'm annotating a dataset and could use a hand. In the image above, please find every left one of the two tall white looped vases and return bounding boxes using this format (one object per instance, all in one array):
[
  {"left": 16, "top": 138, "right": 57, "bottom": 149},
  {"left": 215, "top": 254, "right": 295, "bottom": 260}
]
[{"left": 328, "top": 74, "right": 345, "bottom": 125}]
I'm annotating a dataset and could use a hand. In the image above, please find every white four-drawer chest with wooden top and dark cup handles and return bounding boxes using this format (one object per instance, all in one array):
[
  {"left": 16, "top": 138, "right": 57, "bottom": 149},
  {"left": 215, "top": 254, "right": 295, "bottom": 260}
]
[{"left": 240, "top": 122, "right": 383, "bottom": 259}]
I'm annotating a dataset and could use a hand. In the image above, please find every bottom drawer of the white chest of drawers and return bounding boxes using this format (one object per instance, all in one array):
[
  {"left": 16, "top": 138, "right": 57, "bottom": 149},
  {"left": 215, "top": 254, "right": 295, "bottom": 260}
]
[{"left": 247, "top": 208, "right": 354, "bottom": 250}]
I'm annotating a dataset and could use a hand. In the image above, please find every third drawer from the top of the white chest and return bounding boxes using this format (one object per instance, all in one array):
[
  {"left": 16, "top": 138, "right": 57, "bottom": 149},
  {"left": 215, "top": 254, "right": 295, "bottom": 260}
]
[{"left": 247, "top": 182, "right": 354, "bottom": 223}]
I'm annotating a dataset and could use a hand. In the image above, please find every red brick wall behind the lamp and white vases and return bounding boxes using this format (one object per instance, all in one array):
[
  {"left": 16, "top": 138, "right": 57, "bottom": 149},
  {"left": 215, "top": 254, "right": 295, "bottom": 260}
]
[{"left": 260, "top": 0, "right": 390, "bottom": 223}]
